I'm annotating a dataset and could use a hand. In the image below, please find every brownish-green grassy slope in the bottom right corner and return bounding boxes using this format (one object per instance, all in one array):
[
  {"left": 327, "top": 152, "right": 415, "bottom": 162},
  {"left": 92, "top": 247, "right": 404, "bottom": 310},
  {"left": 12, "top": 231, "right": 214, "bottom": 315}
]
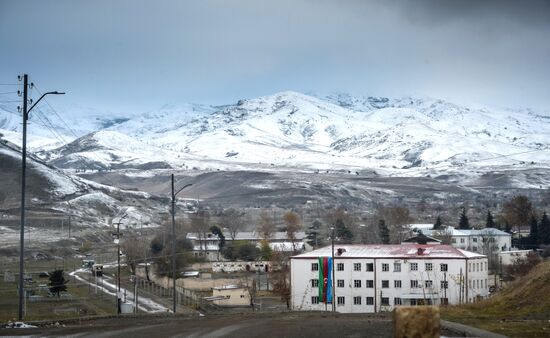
[{"left": 441, "top": 261, "right": 550, "bottom": 338}]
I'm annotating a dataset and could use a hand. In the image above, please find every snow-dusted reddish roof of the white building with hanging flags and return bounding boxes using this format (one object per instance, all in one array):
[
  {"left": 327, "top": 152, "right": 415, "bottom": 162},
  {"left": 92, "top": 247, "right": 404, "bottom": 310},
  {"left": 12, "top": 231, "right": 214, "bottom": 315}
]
[{"left": 292, "top": 244, "right": 486, "bottom": 259}]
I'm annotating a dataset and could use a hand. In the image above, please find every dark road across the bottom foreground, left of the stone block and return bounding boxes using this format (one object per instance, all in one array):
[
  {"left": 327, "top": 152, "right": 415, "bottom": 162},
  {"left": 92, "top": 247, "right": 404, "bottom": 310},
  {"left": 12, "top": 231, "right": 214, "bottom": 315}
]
[{"left": 0, "top": 312, "right": 393, "bottom": 338}]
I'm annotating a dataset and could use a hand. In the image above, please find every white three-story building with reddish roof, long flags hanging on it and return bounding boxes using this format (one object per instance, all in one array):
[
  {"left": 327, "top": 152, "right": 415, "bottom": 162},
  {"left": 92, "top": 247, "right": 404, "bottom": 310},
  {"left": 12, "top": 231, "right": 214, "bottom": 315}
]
[{"left": 291, "top": 244, "right": 489, "bottom": 313}]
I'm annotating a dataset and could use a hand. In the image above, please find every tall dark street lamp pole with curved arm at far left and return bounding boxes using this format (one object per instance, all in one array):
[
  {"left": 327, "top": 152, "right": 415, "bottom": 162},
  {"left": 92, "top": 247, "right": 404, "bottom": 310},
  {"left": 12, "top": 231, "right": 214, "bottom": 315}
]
[{"left": 18, "top": 74, "right": 65, "bottom": 320}]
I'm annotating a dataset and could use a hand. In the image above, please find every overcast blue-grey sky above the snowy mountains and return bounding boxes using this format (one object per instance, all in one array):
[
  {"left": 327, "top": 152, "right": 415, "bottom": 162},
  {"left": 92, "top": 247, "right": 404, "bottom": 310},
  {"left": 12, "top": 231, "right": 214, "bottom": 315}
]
[{"left": 0, "top": 0, "right": 550, "bottom": 111}]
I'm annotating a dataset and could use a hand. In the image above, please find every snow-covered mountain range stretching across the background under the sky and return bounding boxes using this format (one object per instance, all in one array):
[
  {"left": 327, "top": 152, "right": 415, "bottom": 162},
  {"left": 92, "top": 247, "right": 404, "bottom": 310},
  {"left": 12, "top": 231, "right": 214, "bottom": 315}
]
[{"left": 0, "top": 92, "right": 550, "bottom": 176}]
